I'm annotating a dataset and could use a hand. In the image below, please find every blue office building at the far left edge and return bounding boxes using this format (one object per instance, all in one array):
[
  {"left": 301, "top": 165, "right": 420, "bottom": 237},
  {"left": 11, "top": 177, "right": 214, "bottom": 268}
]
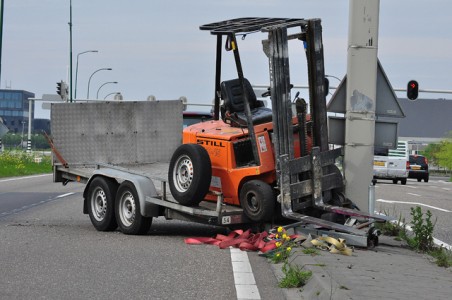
[{"left": 0, "top": 90, "right": 35, "bottom": 133}]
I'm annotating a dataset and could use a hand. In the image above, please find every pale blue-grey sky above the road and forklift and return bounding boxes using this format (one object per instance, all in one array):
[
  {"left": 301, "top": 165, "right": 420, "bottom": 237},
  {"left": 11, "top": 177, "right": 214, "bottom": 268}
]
[{"left": 0, "top": 0, "right": 452, "bottom": 118}]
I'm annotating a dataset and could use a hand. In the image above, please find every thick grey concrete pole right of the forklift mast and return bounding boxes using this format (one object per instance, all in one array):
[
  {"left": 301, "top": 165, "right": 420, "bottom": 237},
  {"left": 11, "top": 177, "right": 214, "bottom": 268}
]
[{"left": 344, "top": 0, "right": 380, "bottom": 211}]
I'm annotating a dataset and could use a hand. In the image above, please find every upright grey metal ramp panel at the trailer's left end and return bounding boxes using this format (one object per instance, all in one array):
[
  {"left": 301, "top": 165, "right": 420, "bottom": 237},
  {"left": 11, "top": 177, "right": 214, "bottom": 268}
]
[{"left": 51, "top": 100, "right": 182, "bottom": 164}]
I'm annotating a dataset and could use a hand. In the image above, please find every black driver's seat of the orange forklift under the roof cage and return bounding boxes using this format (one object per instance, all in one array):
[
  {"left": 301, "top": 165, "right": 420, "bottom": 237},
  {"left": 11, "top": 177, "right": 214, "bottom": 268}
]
[{"left": 221, "top": 78, "right": 272, "bottom": 127}]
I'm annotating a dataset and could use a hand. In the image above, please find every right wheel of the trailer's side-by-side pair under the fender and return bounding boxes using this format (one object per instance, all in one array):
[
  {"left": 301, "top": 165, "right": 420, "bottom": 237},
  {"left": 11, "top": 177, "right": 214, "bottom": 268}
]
[{"left": 115, "top": 181, "right": 152, "bottom": 234}]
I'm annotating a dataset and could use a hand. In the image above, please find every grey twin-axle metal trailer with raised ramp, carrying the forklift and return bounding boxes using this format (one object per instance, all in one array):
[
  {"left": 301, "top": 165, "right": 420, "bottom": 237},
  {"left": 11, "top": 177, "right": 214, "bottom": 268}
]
[{"left": 51, "top": 100, "right": 249, "bottom": 234}]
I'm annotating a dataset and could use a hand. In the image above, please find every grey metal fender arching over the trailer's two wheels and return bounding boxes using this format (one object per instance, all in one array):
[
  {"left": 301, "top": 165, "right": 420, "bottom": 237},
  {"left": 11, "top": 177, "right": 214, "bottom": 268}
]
[{"left": 83, "top": 169, "right": 159, "bottom": 217}]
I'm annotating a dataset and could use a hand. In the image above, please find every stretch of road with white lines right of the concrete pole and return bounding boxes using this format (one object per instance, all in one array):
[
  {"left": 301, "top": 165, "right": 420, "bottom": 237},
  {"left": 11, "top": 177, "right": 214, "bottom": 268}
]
[{"left": 375, "top": 177, "right": 452, "bottom": 245}]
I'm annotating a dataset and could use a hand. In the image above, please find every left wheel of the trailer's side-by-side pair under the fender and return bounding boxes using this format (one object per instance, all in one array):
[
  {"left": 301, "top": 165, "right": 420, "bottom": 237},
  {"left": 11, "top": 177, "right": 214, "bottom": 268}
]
[{"left": 87, "top": 177, "right": 118, "bottom": 231}]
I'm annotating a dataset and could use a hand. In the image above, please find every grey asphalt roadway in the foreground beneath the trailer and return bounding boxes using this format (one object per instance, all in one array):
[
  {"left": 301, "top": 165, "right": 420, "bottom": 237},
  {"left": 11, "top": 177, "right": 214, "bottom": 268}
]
[{"left": 0, "top": 176, "right": 284, "bottom": 299}]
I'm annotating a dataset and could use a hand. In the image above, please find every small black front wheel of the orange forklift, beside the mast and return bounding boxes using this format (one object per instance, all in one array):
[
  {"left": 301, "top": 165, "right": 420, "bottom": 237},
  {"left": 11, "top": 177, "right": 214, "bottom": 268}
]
[{"left": 240, "top": 180, "right": 276, "bottom": 222}]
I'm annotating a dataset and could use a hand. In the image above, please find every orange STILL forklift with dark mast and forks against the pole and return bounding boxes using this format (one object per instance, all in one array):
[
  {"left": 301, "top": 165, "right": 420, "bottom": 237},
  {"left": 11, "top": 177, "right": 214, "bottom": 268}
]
[{"left": 168, "top": 18, "right": 382, "bottom": 235}]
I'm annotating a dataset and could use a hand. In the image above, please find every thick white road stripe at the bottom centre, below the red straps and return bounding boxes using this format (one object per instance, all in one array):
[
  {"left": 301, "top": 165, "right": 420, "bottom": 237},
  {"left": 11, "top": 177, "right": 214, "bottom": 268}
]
[{"left": 231, "top": 248, "right": 261, "bottom": 300}]
